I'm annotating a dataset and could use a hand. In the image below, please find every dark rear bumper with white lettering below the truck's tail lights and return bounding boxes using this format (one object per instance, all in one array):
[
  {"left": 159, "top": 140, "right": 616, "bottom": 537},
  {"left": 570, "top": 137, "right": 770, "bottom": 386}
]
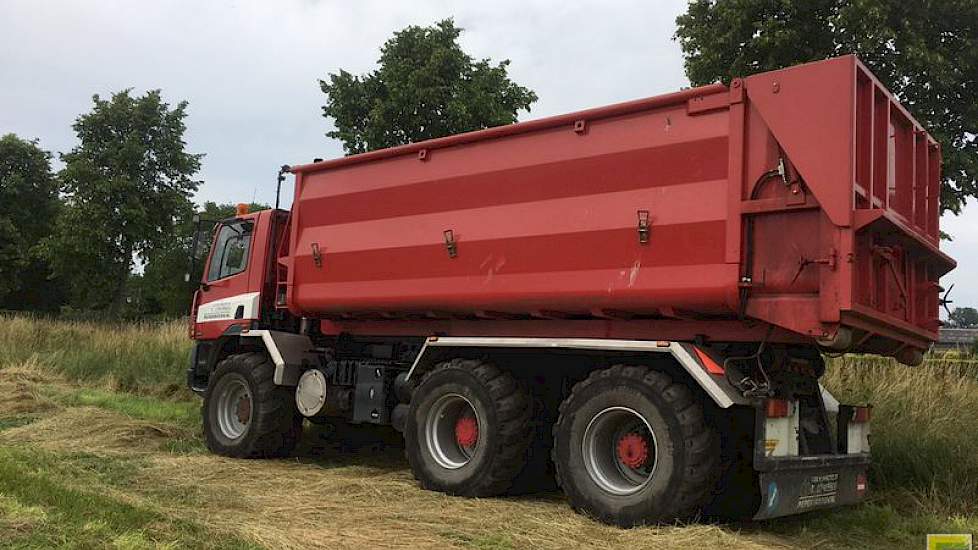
[{"left": 754, "top": 454, "right": 870, "bottom": 519}]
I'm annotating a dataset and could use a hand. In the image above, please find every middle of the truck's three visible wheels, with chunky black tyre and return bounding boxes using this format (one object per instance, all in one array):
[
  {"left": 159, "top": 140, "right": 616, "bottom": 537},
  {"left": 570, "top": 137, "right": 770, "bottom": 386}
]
[{"left": 404, "top": 359, "right": 532, "bottom": 497}]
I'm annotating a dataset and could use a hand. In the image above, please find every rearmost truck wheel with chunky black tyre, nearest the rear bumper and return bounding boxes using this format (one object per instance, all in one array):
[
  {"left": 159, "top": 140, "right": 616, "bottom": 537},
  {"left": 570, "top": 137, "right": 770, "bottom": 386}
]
[{"left": 553, "top": 365, "right": 720, "bottom": 527}]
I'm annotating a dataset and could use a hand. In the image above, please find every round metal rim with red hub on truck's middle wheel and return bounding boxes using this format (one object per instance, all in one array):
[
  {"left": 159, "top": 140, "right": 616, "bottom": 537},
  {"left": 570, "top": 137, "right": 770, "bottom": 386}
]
[{"left": 425, "top": 393, "right": 483, "bottom": 470}]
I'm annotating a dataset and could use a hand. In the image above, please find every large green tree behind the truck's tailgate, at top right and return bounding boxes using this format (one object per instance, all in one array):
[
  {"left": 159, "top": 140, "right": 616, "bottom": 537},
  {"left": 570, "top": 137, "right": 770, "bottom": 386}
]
[{"left": 676, "top": 0, "right": 978, "bottom": 214}]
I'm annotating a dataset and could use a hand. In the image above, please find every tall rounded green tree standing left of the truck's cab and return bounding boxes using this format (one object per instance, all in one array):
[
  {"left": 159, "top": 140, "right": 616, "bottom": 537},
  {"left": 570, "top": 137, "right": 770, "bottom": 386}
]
[{"left": 43, "top": 90, "right": 202, "bottom": 311}]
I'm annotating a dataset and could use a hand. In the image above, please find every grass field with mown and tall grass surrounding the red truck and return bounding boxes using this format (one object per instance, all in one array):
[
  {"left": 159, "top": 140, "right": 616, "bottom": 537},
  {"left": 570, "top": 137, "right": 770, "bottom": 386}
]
[{"left": 0, "top": 317, "right": 978, "bottom": 550}]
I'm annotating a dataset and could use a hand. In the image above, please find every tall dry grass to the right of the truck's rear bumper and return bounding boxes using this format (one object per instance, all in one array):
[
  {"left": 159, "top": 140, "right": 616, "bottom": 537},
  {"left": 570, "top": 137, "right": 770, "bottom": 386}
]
[{"left": 823, "top": 356, "right": 978, "bottom": 515}]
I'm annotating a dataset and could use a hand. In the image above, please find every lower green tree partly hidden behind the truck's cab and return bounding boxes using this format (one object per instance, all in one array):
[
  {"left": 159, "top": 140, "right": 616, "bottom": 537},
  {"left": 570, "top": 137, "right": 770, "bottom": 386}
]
[{"left": 133, "top": 201, "right": 271, "bottom": 317}]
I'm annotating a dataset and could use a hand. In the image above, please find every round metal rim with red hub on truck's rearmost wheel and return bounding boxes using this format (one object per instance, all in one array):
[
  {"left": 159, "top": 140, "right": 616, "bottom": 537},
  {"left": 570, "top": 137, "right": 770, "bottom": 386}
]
[{"left": 581, "top": 407, "right": 658, "bottom": 496}]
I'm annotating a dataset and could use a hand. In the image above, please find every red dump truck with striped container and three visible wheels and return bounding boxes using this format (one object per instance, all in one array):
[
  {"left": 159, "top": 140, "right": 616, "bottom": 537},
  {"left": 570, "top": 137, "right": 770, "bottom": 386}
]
[{"left": 188, "top": 56, "right": 955, "bottom": 525}]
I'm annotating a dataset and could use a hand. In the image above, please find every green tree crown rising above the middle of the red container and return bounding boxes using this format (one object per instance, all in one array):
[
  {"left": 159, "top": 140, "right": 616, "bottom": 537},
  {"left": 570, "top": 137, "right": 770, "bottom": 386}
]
[{"left": 319, "top": 19, "right": 537, "bottom": 154}]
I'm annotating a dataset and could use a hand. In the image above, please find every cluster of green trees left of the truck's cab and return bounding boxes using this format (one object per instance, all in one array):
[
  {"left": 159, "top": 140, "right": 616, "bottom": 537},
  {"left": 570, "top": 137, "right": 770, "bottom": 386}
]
[{"left": 0, "top": 115, "right": 268, "bottom": 317}]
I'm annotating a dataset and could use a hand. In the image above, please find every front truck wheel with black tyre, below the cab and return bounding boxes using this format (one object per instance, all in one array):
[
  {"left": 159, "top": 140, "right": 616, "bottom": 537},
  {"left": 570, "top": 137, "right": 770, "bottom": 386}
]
[{"left": 201, "top": 353, "right": 302, "bottom": 458}]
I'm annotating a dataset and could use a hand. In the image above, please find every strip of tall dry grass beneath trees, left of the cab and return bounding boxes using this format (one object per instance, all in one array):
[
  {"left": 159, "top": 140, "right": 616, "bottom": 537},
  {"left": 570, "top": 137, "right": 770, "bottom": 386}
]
[{"left": 0, "top": 315, "right": 191, "bottom": 398}]
